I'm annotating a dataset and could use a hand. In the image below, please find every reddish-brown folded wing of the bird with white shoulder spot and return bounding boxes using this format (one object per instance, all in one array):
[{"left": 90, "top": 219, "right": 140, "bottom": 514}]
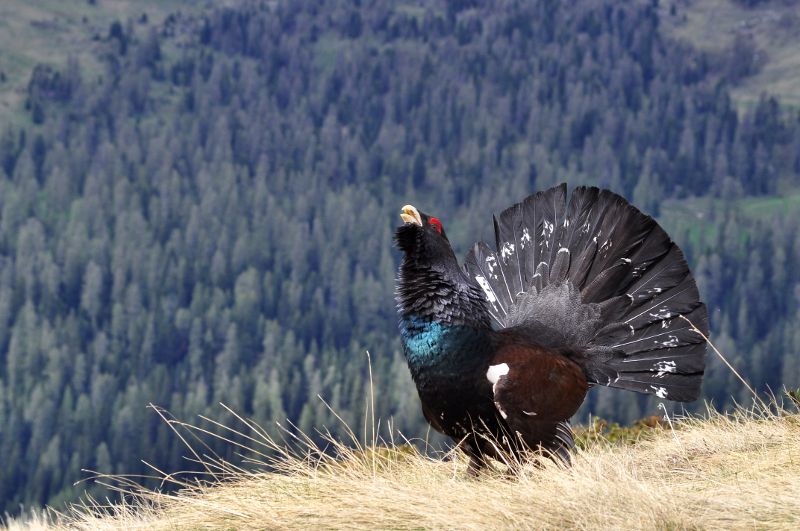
[{"left": 486, "top": 345, "right": 588, "bottom": 461}]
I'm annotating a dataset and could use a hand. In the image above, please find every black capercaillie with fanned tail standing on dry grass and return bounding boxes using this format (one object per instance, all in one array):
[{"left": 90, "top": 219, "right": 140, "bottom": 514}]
[{"left": 395, "top": 184, "right": 708, "bottom": 473}]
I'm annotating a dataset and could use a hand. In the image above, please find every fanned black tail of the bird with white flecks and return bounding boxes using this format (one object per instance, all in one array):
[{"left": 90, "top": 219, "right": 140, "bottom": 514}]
[{"left": 464, "top": 184, "right": 708, "bottom": 400}]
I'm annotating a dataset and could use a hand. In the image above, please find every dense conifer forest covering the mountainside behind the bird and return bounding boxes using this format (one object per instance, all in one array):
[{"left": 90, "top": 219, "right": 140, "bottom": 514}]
[{"left": 0, "top": 0, "right": 800, "bottom": 511}]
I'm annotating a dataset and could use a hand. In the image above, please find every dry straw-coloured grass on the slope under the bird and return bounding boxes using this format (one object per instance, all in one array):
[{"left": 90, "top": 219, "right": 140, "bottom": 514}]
[{"left": 10, "top": 402, "right": 800, "bottom": 531}]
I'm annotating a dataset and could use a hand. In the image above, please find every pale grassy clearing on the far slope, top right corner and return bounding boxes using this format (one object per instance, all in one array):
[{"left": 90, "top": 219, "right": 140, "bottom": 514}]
[{"left": 661, "top": 0, "right": 800, "bottom": 107}]
